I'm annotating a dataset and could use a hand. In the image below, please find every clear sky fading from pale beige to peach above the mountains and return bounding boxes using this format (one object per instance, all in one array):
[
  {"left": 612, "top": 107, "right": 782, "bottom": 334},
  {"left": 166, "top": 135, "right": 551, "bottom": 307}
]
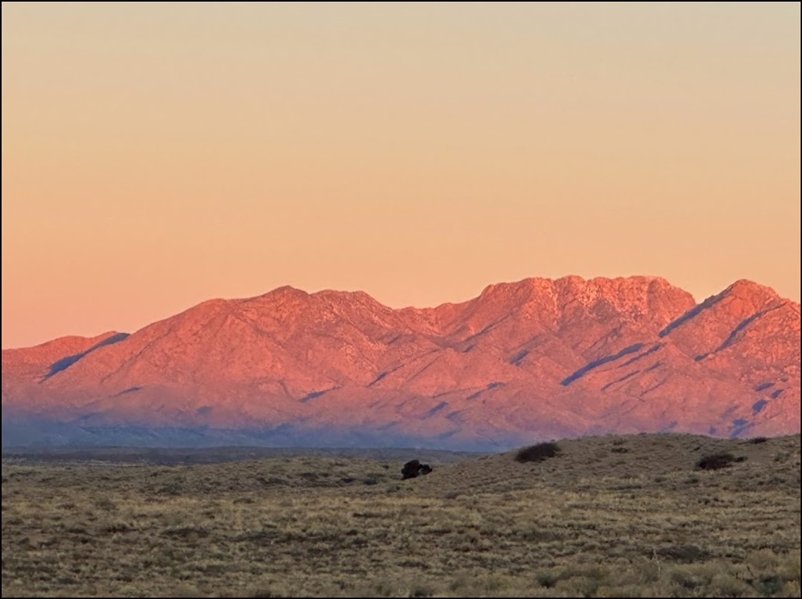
[{"left": 2, "top": 3, "right": 800, "bottom": 348}]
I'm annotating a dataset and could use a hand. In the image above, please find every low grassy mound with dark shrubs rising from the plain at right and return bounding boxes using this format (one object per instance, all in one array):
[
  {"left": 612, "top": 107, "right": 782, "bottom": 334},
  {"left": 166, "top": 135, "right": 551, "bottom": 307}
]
[{"left": 415, "top": 434, "right": 800, "bottom": 496}]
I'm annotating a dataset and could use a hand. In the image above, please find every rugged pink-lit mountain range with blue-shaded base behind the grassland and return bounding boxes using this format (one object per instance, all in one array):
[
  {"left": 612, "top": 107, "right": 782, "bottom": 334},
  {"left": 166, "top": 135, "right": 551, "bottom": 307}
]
[{"left": 2, "top": 277, "right": 800, "bottom": 449}]
